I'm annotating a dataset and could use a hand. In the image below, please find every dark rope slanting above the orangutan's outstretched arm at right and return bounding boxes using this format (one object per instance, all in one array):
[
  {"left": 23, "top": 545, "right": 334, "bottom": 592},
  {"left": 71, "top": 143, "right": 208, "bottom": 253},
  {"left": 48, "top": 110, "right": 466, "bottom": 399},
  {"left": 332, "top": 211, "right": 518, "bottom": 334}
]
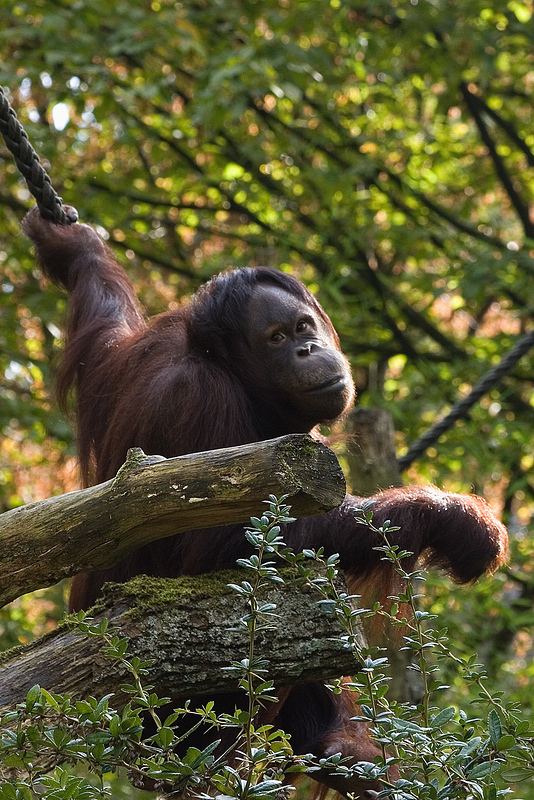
[{"left": 397, "top": 330, "right": 534, "bottom": 470}]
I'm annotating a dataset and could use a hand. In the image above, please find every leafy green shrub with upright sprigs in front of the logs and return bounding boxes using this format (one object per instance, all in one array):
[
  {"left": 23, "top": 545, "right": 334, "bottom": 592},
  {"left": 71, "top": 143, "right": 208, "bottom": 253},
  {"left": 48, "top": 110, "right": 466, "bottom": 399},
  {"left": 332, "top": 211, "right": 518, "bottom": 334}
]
[{"left": 0, "top": 498, "right": 534, "bottom": 800}]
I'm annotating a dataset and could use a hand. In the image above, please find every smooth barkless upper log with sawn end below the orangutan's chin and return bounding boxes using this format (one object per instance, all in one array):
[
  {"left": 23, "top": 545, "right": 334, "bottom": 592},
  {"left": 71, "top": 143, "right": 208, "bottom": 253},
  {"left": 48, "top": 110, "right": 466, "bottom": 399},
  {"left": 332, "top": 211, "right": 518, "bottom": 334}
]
[{"left": 0, "top": 434, "right": 345, "bottom": 606}]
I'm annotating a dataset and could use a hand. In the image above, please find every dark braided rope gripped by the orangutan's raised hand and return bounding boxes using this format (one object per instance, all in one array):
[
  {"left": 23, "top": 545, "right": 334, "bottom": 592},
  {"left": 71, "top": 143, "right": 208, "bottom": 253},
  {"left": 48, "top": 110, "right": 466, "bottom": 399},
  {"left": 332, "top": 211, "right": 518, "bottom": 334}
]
[{"left": 0, "top": 86, "right": 76, "bottom": 225}]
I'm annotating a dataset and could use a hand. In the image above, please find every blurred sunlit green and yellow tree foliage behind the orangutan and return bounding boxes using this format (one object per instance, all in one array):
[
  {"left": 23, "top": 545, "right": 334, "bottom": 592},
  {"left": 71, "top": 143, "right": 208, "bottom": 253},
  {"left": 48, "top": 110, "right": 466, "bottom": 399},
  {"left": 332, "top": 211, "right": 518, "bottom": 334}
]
[{"left": 0, "top": 0, "right": 534, "bottom": 798}]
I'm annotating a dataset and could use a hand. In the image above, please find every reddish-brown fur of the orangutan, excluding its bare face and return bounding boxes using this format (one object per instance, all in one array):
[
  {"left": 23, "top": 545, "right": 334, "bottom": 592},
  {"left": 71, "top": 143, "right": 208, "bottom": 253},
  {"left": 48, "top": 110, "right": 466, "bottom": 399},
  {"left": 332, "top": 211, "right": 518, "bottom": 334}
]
[{"left": 24, "top": 205, "right": 507, "bottom": 792}]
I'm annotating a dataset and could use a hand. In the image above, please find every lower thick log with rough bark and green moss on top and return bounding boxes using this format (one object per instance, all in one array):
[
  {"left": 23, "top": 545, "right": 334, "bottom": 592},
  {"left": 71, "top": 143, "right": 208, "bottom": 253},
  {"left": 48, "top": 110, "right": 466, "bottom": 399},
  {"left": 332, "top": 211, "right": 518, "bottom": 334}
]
[{"left": 0, "top": 570, "right": 364, "bottom": 711}]
